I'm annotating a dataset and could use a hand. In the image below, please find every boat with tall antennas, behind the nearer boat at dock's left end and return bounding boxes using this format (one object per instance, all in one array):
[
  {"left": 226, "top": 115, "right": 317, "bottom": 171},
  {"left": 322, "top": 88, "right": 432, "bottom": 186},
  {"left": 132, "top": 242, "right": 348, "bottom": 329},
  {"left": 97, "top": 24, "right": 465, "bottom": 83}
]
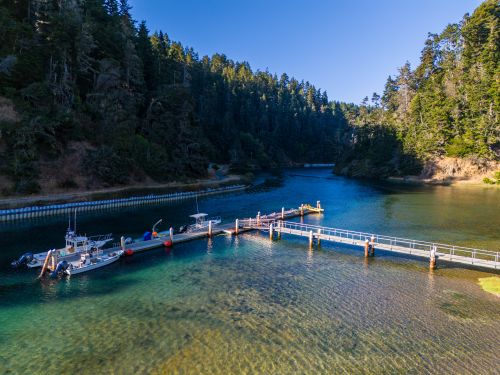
[{"left": 11, "top": 216, "right": 113, "bottom": 268}]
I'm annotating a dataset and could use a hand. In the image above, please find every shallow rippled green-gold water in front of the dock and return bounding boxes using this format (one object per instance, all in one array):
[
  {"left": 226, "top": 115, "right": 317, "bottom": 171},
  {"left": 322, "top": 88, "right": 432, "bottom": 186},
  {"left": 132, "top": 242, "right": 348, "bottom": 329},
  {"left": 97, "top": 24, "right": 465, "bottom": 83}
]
[{"left": 0, "top": 235, "right": 500, "bottom": 374}]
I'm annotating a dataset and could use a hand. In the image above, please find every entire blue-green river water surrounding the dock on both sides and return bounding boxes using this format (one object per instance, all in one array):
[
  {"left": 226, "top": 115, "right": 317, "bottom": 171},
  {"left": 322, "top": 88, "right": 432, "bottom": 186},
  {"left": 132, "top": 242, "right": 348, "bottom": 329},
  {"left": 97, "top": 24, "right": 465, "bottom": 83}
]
[{"left": 0, "top": 170, "right": 500, "bottom": 374}]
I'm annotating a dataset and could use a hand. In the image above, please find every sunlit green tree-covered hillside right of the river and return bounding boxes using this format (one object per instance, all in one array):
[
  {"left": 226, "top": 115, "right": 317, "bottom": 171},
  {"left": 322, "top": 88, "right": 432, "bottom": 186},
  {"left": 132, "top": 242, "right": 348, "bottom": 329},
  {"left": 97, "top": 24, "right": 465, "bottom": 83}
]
[{"left": 338, "top": 0, "right": 500, "bottom": 177}]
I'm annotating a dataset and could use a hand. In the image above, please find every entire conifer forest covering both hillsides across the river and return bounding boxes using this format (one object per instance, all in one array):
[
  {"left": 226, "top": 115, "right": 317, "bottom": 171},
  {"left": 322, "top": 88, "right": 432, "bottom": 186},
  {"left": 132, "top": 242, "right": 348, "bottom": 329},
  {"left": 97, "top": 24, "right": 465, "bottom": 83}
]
[{"left": 0, "top": 0, "right": 500, "bottom": 194}]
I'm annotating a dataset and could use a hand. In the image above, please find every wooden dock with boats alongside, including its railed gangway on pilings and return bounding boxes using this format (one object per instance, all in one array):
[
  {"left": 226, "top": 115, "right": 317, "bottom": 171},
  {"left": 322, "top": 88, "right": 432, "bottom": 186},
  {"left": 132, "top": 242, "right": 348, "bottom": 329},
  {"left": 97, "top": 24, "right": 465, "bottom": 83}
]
[{"left": 40, "top": 201, "right": 500, "bottom": 270}]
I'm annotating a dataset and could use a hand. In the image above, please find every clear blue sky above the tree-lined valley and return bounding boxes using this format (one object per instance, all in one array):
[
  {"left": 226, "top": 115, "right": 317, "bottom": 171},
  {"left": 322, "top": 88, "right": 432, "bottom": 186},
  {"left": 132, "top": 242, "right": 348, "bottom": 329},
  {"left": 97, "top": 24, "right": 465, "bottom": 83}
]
[{"left": 129, "top": 0, "right": 481, "bottom": 103}]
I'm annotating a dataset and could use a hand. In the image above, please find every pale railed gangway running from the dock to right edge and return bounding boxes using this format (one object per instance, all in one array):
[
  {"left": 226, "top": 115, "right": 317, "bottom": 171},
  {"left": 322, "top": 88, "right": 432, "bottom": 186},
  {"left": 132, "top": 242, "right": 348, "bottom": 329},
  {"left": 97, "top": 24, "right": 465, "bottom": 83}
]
[{"left": 276, "top": 220, "right": 500, "bottom": 269}]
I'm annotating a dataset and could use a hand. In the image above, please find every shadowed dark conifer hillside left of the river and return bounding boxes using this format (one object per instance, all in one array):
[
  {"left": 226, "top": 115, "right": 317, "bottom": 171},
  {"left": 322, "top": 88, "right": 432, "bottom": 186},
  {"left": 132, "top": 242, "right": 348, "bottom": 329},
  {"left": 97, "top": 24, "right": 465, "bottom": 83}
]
[{"left": 0, "top": 0, "right": 346, "bottom": 194}]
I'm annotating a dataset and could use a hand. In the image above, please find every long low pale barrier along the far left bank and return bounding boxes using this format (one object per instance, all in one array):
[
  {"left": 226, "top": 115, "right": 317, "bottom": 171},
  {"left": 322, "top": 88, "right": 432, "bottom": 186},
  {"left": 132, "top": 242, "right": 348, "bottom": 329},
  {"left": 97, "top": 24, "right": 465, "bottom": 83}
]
[{"left": 0, "top": 175, "right": 248, "bottom": 209}]
